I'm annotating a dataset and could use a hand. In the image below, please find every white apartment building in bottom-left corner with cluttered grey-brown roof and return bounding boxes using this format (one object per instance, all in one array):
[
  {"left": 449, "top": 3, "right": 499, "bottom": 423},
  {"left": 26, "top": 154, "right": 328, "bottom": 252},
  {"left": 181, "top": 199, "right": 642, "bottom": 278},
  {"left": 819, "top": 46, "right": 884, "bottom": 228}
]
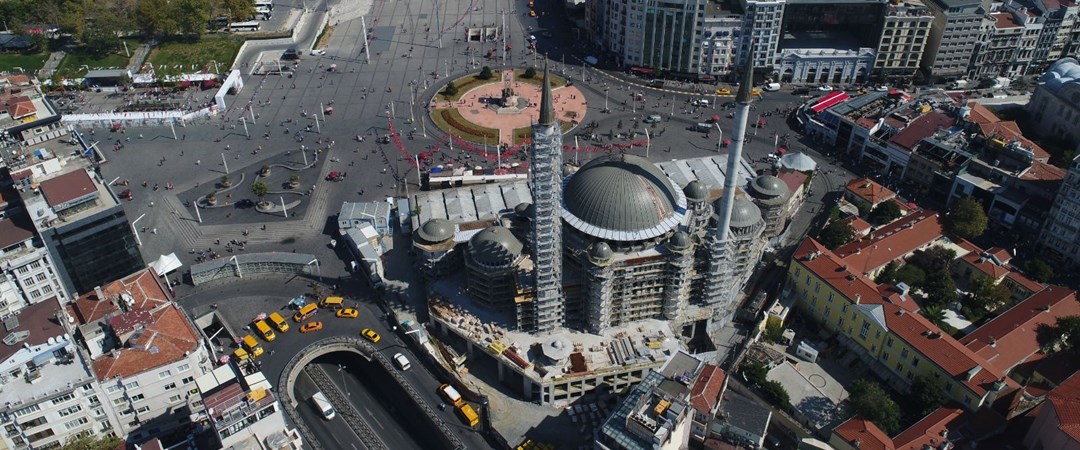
[{"left": 0, "top": 300, "right": 119, "bottom": 450}]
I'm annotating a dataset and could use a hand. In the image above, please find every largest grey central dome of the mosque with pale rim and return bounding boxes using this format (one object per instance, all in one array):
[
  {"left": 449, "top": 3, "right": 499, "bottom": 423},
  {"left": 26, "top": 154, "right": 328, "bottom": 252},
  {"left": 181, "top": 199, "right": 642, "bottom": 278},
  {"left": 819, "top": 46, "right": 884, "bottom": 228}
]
[{"left": 563, "top": 154, "right": 686, "bottom": 241}]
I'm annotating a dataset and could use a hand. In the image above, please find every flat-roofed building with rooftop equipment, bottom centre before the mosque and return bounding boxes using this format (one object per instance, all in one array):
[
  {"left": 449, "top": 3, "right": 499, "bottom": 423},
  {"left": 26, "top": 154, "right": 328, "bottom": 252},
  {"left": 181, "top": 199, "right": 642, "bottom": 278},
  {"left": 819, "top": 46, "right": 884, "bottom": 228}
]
[{"left": 595, "top": 352, "right": 705, "bottom": 450}]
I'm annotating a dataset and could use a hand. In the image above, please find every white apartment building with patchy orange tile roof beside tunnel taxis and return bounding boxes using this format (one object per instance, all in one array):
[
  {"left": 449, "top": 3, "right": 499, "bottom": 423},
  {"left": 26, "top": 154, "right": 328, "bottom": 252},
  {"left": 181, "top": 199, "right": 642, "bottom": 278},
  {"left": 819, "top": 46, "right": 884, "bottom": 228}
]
[{"left": 64, "top": 269, "right": 213, "bottom": 441}]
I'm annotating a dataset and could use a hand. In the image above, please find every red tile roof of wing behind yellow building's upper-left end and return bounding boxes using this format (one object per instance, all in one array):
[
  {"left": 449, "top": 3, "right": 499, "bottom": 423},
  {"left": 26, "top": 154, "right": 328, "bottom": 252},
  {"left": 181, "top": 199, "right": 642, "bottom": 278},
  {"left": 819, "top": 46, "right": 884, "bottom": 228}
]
[{"left": 834, "top": 209, "right": 943, "bottom": 274}]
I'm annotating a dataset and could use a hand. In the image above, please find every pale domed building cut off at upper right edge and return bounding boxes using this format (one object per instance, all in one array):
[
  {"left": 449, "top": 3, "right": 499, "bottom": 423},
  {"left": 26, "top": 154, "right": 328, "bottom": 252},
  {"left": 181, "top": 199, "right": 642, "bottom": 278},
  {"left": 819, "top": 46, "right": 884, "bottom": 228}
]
[{"left": 1027, "top": 58, "right": 1080, "bottom": 147}]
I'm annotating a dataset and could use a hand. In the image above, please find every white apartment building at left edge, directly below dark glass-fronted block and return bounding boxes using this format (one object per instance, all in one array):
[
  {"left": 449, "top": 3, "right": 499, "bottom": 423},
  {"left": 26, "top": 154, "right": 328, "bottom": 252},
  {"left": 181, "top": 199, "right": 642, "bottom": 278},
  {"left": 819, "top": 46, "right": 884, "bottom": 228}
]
[{"left": 0, "top": 213, "right": 69, "bottom": 317}]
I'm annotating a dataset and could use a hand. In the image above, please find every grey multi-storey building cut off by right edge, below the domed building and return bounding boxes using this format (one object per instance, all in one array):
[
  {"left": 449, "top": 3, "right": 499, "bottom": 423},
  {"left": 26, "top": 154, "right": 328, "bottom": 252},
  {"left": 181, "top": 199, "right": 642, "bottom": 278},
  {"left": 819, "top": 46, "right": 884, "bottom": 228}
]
[{"left": 1039, "top": 155, "right": 1080, "bottom": 268}]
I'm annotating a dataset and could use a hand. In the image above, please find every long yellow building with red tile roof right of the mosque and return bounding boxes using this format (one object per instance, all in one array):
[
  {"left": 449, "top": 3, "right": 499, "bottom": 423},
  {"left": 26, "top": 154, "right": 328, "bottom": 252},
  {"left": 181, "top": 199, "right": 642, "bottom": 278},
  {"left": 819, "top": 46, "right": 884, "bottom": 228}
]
[{"left": 781, "top": 237, "right": 1016, "bottom": 411}]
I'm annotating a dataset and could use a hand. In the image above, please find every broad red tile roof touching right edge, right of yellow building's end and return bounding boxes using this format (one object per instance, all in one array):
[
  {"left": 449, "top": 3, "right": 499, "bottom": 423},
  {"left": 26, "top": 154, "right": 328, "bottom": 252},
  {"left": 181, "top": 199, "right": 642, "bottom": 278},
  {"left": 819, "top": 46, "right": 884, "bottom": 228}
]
[{"left": 960, "top": 286, "right": 1080, "bottom": 371}]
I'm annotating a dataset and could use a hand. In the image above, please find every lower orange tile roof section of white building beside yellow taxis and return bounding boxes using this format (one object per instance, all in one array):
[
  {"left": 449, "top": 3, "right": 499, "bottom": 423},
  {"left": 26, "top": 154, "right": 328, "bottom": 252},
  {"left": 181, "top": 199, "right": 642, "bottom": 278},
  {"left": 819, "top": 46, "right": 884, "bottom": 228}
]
[{"left": 93, "top": 303, "right": 200, "bottom": 381}]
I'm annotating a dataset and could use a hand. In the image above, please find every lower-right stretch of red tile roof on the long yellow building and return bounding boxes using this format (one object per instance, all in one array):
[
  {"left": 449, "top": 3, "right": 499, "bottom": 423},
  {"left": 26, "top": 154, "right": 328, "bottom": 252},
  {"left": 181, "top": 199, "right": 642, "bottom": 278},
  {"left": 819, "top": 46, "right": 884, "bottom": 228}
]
[{"left": 885, "top": 303, "right": 1017, "bottom": 396}]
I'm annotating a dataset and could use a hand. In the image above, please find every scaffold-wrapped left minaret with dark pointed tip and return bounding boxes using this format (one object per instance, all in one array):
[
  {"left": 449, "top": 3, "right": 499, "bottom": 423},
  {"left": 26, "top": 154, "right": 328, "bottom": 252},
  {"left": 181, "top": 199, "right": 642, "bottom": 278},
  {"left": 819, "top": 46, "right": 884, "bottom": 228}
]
[{"left": 529, "top": 62, "right": 566, "bottom": 332}]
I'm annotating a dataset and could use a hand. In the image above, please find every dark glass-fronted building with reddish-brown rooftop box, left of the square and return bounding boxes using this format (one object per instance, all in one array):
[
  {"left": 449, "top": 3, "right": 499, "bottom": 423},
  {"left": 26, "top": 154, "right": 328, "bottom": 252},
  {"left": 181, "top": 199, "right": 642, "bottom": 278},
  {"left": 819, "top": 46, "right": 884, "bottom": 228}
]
[{"left": 12, "top": 166, "right": 143, "bottom": 292}]
